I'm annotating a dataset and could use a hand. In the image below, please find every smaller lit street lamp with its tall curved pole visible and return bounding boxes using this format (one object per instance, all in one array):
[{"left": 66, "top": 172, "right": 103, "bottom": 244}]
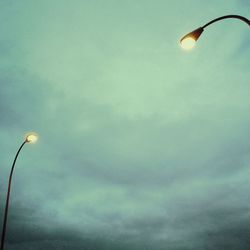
[{"left": 0, "top": 133, "right": 38, "bottom": 250}]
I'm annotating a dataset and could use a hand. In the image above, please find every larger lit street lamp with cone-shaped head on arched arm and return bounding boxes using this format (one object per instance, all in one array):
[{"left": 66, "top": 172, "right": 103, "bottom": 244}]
[{"left": 180, "top": 15, "right": 250, "bottom": 50}]
